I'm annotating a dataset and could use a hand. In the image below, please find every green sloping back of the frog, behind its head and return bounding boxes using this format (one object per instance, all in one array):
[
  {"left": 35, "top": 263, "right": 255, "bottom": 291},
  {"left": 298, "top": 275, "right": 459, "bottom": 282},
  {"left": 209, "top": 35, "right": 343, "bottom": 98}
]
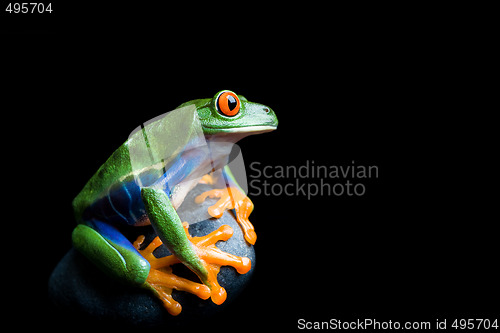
[{"left": 73, "top": 108, "right": 200, "bottom": 223}]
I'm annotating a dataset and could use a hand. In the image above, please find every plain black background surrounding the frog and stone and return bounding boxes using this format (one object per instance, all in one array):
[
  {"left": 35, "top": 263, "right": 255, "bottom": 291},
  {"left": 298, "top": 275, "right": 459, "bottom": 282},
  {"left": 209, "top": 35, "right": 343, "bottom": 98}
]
[{"left": 2, "top": 3, "right": 499, "bottom": 329}]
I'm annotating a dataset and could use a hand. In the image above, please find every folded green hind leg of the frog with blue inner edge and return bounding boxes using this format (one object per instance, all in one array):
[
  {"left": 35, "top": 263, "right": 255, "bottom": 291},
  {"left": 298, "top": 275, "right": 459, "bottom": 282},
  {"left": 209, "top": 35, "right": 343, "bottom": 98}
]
[{"left": 73, "top": 220, "right": 150, "bottom": 286}]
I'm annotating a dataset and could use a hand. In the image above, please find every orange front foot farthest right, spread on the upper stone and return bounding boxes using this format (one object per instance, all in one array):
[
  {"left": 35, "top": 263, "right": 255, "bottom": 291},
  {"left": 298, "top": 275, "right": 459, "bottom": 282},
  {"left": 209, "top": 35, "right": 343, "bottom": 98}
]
[{"left": 195, "top": 186, "right": 257, "bottom": 245}]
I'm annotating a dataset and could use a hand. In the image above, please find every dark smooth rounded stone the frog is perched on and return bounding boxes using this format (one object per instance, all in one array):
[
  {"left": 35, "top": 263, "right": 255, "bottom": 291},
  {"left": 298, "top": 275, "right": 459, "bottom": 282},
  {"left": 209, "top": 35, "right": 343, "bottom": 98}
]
[{"left": 49, "top": 185, "right": 255, "bottom": 326}]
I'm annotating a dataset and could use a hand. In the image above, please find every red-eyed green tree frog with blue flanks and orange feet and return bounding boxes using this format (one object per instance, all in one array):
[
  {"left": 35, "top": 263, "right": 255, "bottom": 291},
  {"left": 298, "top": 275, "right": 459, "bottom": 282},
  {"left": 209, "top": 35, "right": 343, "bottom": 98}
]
[{"left": 72, "top": 90, "right": 278, "bottom": 316}]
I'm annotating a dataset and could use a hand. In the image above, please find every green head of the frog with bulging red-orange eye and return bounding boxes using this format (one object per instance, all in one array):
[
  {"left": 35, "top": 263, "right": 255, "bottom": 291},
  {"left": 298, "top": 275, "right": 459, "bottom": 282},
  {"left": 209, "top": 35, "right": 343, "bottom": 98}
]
[{"left": 180, "top": 90, "right": 278, "bottom": 141}]
